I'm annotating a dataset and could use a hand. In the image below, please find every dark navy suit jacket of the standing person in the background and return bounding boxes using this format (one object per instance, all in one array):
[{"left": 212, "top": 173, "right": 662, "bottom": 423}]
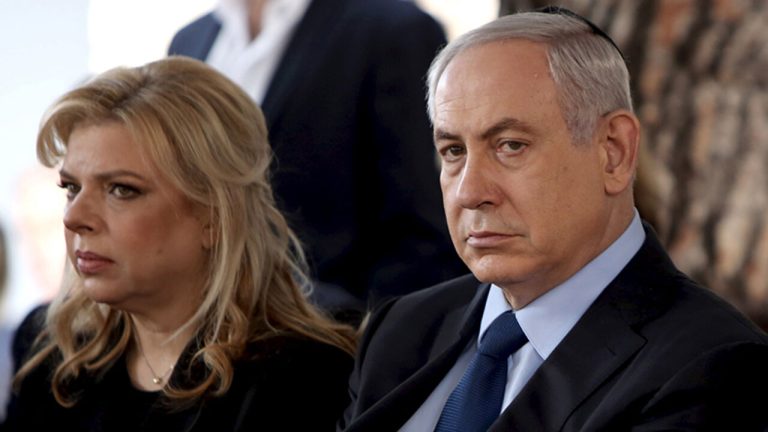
[{"left": 169, "top": 0, "right": 466, "bottom": 310}]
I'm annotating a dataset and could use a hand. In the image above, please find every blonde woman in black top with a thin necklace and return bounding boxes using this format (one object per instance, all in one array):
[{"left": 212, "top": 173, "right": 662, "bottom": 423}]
[{"left": 6, "top": 57, "right": 355, "bottom": 431}]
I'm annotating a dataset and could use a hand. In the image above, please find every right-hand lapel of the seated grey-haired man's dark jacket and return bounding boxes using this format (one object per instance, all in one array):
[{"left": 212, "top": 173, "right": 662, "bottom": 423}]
[{"left": 490, "top": 225, "right": 677, "bottom": 431}]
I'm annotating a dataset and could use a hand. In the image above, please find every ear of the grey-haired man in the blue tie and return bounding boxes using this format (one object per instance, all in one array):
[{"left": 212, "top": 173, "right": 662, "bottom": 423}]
[{"left": 598, "top": 110, "right": 640, "bottom": 195}]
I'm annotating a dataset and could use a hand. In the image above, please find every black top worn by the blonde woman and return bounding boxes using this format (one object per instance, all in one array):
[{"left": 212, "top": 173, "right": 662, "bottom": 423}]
[{"left": 2, "top": 309, "right": 352, "bottom": 432}]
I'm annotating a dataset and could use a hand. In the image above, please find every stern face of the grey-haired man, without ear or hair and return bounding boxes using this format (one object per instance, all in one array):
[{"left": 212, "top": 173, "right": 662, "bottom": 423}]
[{"left": 434, "top": 40, "right": 610, "bottom": 307}]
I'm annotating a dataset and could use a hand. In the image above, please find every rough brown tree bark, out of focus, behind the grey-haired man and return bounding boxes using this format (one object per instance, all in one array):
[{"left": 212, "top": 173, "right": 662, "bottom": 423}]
[{"left": 501, "top": 0, "right": 768, "bottom": 329}]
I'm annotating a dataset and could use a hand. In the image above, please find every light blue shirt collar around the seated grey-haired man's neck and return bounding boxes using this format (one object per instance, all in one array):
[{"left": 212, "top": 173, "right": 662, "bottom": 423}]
[{"left": 478, "top": 210, "right": 645, "bottom": 360}]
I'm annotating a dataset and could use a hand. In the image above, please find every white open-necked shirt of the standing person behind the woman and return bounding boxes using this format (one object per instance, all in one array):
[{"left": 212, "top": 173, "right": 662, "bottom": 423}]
[{"left": 205, "top": 0, "right": 311, "bottom": 104}]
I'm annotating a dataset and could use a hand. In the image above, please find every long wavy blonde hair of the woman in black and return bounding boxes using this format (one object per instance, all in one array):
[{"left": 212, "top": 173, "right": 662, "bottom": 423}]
[{"left": 16, "top": 57, "right": 355, "bottom": 406}]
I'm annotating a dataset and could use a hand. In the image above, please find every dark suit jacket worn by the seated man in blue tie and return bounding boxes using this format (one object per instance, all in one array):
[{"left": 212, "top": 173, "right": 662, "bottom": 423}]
[{"left": 341, "top": 229, "right": 768, "bottom": 431}]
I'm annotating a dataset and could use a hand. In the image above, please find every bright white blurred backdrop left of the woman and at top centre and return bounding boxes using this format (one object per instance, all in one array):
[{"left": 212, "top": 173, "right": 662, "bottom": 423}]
[{"left": 0, "top": 0, "right": 499, "bottom": 326}]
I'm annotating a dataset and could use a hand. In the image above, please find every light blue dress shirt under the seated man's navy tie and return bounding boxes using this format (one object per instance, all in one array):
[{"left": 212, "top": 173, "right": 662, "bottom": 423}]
[{"left": 400, "top": 210, "right": 645, "bottom": 432}]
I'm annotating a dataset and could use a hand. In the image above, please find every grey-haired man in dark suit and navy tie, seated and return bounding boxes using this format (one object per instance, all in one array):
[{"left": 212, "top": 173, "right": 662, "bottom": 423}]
[{"left": 340, "top": 8, "right": 768, "bottom": 432}]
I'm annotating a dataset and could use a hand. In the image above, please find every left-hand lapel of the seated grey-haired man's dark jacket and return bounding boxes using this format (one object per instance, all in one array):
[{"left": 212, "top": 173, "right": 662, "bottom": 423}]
[{"left": 349, "top": 284, "right": 489, "bottom": 431}]
